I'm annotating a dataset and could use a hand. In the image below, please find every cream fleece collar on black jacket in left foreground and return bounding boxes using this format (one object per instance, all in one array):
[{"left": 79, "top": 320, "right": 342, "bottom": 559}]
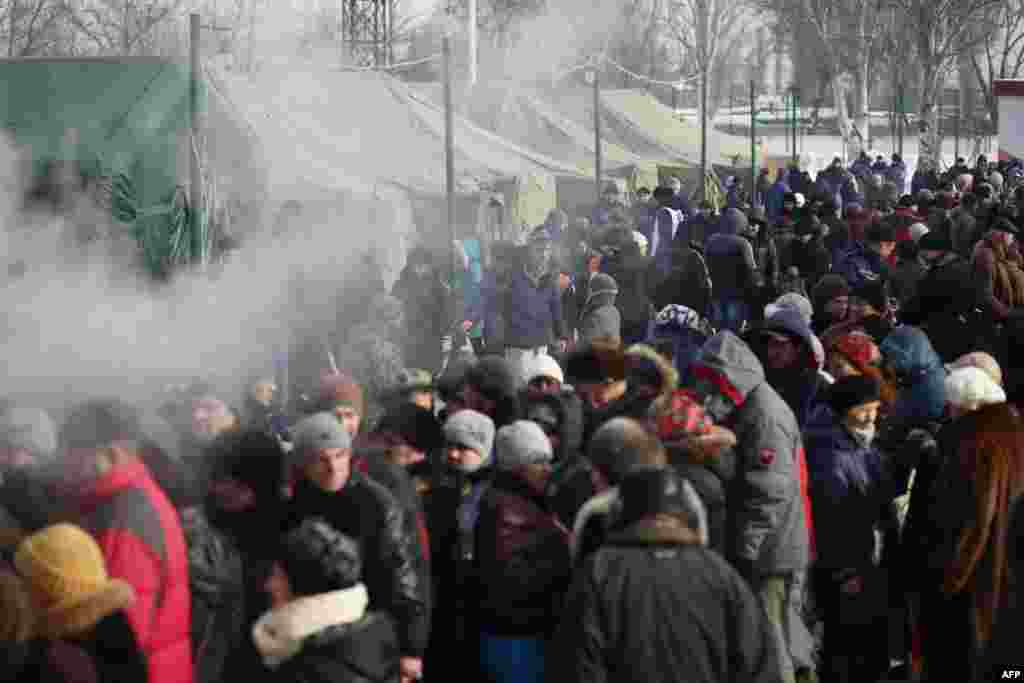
[{"left": 253, "top": 584, "right": 370, "bottom": 669}]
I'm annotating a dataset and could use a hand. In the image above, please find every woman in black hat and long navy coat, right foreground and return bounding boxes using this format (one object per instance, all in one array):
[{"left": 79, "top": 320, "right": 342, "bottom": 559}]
[{"left": 806, "top": 375, "right": 910, "bottom": 681}]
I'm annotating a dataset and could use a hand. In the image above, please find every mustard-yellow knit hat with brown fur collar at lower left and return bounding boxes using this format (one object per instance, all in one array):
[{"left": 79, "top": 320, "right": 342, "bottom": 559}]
[{"left": 14, "top": 524, "right": 135, "bottom": 638}]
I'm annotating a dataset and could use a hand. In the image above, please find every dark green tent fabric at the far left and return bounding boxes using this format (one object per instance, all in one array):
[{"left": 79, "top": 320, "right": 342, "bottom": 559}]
[{"left": 0, "top": 58, "right": 216, "bottom": 276}]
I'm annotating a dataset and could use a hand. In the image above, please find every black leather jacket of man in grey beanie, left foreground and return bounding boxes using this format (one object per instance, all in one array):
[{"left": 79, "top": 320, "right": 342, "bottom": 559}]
[{"left": 285, "top": 472, "right": 429, "bottom": 656}]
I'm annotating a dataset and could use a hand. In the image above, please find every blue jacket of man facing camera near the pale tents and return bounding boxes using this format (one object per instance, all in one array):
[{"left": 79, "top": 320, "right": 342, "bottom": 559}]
[{"left": 484, "top": 268, "right": 567, "bottom": 348}]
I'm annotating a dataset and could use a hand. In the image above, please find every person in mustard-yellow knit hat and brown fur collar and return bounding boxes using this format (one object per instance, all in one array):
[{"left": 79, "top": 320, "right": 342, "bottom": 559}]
[{"left": 14, "top": 523, "right": 152, "bottom": 683}]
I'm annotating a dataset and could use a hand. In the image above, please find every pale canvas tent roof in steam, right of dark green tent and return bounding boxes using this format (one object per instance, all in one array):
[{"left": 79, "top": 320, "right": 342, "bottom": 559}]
[{"left": 209, "top": 65, "right": 577, "bottom": 240}]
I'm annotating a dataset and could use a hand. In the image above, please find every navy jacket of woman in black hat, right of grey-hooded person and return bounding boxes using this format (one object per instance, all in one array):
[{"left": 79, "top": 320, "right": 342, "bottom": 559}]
[{"left": 804, "top": 413, "right": 910, "bottom": 569}]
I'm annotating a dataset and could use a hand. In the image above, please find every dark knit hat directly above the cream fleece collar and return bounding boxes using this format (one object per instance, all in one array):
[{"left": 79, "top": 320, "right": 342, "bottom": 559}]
[{"left": 274, "top": 517, "right": 362, "bottom": 595}]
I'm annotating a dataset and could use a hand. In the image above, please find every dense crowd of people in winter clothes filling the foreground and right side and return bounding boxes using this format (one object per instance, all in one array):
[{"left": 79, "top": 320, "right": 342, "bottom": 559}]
[{"left": 0, "top": 149, "right": 1024, "bottom": 683}]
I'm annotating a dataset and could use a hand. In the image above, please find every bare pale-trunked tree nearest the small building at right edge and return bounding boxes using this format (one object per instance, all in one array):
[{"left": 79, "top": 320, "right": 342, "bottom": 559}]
[{"left": 891, "top": 0, "right": 1006, "bottom": 169}]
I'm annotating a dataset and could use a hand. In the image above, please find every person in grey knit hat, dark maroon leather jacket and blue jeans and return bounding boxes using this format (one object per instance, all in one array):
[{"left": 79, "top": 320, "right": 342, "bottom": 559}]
[{"left": 475, "top": 420, "right": 570, "bottom": 683}]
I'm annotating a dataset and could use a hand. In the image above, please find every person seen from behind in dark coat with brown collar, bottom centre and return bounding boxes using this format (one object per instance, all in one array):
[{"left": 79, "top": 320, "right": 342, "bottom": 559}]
[{"left": 548, "top": 465, "right": 780, "bottom": 683}]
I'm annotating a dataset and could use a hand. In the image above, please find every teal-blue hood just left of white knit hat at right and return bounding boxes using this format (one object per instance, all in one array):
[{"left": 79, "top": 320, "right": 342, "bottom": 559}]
[{"left": 879, "top": 326, "right": 946, "bottom": 420}]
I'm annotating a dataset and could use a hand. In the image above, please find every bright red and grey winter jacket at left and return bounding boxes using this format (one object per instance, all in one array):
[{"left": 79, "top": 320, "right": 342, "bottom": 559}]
[{"left": 80, "top": 461, "right": 194, "bottom": 683}]
